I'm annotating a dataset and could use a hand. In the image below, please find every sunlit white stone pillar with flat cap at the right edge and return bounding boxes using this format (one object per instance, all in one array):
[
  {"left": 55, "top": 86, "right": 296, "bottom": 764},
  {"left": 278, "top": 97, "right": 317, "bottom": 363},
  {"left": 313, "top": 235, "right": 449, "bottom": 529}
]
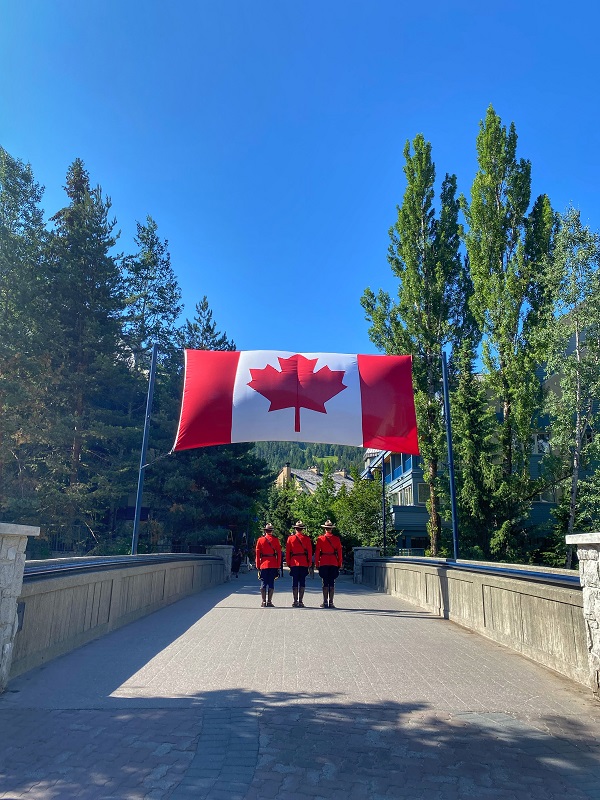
[{"left": 566, "top": 533, "right": 600, "bottom": 700}]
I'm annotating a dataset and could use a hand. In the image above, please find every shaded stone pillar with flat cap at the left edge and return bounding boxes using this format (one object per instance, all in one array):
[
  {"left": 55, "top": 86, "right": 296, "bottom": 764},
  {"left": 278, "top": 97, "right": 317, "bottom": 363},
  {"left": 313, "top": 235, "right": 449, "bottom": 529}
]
[{"left": 0, "top": 522, "right": 40, "bottom": 692}]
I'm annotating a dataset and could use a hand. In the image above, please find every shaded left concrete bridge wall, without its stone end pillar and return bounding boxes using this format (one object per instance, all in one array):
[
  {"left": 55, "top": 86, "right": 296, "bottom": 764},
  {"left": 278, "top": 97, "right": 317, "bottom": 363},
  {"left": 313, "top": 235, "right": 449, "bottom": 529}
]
[{"left": 9, "top": 555, "right": 225, "bottom": 678}]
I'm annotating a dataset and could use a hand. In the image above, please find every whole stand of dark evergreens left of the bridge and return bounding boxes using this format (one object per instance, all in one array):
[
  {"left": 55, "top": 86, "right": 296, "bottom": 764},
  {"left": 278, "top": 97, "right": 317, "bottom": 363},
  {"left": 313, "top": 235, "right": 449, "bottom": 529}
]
[{"left": 0, "top": 148, "right": 272, "bottom": 557}]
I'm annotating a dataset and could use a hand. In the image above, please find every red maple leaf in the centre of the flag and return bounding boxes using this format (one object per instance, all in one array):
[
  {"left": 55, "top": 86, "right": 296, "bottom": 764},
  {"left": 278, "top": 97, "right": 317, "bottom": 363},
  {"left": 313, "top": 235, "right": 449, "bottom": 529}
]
[{"left": 248, "top": 353, "right": 347, "bottom": 433}]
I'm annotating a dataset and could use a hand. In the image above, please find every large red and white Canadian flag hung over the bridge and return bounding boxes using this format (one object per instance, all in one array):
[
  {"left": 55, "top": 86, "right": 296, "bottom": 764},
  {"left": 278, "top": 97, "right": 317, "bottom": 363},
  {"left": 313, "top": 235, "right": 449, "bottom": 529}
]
[{"left": 174, "top": 350, "right": 419, "bottom": 455}]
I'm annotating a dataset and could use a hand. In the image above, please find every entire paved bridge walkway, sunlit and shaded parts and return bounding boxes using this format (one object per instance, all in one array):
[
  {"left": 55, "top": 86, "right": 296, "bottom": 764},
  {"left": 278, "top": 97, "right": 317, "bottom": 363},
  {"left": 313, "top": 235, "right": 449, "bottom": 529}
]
[{"left": 0, "top": 576, "right": 600, "bottom": 800}]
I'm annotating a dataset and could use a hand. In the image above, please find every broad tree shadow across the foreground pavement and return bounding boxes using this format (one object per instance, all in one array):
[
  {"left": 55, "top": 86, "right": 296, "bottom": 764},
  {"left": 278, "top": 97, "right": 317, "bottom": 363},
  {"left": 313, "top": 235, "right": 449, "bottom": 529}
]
[{"left": 0, "top": 691, "right": 600, "bottom": 800}]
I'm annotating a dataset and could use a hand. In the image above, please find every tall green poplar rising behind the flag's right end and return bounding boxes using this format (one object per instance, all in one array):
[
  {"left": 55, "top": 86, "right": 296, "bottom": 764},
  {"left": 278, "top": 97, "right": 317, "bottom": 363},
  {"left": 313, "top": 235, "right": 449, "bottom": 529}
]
[{"left": 361, "top": 134, "right": 468, "bottom": 555}]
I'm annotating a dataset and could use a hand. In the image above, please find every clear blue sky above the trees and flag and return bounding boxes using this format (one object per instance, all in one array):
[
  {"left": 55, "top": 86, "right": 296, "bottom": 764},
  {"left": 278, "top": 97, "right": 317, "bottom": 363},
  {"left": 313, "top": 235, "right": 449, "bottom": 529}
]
[{"left": 0, "top": 0, "right": 600, "bottom": 353}]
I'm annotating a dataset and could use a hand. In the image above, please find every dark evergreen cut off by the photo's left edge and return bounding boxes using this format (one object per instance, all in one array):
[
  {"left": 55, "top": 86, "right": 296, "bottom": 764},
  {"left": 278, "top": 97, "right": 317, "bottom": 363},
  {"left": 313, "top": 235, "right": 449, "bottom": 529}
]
[{"left": 0, "top": 147, "right": 48, "bottom": 523}]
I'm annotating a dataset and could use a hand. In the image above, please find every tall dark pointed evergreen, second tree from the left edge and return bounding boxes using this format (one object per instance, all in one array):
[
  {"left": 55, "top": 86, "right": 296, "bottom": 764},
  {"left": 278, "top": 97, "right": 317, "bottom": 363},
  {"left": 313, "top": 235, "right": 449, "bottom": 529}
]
[{"left": 44, "top": 159, "right": 133, "bottom": 552}]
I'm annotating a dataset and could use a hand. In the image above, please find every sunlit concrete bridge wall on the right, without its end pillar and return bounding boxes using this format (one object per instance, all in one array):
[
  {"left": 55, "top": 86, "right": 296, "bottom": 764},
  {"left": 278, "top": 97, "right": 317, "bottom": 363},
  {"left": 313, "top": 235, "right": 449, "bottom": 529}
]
[{"left": 362, "top": 558, "right": 588, "bottom": 688}]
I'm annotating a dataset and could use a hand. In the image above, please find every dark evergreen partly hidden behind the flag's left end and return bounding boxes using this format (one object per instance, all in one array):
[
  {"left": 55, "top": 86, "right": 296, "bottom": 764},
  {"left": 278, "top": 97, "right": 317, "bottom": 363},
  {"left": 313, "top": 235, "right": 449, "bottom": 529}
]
[{"left": 140, "top": 297, "right": 275, "bottom": 550}]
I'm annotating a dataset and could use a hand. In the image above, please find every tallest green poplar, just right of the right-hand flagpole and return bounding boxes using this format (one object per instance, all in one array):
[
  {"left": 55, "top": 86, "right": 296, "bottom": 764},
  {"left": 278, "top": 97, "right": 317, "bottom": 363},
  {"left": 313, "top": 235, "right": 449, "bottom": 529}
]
[{"left": 461, "top": 106, "right": 555, "bottom": 554}]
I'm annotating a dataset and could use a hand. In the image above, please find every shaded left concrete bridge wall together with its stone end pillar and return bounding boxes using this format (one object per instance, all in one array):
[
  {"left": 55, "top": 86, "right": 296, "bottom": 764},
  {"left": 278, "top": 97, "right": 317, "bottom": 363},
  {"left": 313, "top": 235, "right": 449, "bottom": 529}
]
[{"left": 0, "top": 524, "right": 232, "bottom": 692}]
